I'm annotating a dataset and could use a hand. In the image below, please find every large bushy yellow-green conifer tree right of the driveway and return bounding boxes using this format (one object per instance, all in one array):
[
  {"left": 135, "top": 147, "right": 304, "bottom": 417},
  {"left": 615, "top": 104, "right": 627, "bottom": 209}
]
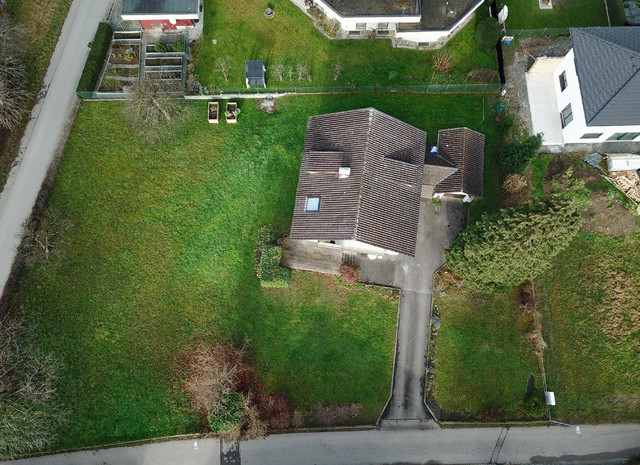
[{"left": 446, "top": 200, "right": 580, "bottom": 293}]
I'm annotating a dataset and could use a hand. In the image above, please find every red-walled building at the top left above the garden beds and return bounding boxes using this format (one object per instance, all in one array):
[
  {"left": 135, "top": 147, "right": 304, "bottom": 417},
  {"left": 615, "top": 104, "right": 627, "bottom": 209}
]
[{"left": 121, "top": 0, "right": 201, "bottom": 30}]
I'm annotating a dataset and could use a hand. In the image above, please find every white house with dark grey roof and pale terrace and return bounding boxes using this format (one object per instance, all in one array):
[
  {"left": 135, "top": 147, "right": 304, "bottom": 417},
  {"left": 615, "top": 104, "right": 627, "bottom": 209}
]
[{"left": 526, "top": 27, "right": 640, "bottom": 145}]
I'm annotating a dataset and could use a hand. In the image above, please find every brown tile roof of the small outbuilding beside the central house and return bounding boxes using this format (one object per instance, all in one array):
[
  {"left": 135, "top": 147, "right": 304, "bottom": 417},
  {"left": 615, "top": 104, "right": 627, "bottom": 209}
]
[{"left": 432, "top": 128, "right": 484, "bottom": 198}]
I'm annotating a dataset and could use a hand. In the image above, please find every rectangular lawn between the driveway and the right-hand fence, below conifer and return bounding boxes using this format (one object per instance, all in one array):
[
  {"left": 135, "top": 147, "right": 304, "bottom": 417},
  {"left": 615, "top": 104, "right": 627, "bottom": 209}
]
[{"left": 434, "top": 285, "right": 541, "bottom": 421}]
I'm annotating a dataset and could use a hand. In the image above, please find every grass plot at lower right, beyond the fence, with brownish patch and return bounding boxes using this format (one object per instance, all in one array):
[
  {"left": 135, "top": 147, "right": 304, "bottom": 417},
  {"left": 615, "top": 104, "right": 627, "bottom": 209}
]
[{"left": 541, "top": 233, "right": 640, "bottom": 422}]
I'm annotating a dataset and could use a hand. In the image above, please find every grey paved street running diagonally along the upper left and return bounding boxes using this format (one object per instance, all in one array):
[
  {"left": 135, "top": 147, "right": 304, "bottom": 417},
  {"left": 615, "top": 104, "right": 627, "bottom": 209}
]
[{"left": 0, "top": 0, "right": 112, "bottom": 294}]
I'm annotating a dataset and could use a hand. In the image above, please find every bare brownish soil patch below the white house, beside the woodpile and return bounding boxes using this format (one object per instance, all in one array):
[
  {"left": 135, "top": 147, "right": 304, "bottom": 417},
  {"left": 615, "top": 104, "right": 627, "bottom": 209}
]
[{"left": 543, "top": 154, "right": 640, "bottom": 237}]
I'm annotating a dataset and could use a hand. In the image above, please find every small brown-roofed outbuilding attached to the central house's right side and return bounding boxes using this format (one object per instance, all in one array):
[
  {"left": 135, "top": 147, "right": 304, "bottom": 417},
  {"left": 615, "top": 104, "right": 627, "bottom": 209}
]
[{"left": 422, "top": 128, "right": 484, "bottom": 202}]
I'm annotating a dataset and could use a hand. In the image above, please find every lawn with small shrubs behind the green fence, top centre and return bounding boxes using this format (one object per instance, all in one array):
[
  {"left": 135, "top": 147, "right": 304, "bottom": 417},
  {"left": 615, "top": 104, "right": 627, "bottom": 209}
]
[{"left": 195, "top": 0, "right": 497, "bottom": 89}]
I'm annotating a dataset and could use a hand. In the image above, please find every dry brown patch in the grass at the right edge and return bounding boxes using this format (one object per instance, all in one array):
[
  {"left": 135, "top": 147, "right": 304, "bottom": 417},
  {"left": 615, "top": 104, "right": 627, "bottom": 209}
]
[{"left": 596, "top": 270, "right": 640, "bottom": 345}]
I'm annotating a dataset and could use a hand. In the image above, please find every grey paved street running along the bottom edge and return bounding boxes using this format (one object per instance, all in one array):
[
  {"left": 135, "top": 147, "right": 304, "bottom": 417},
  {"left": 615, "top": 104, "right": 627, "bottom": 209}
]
[{"left": 12, "top": 424, "right": 640, "bottom": 465}]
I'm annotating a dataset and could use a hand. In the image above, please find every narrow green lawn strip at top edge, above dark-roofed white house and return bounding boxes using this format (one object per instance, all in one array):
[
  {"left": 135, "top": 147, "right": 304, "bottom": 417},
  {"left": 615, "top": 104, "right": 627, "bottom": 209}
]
[{"left": 498, "top": 0, "right": 625, "bottom": 30}]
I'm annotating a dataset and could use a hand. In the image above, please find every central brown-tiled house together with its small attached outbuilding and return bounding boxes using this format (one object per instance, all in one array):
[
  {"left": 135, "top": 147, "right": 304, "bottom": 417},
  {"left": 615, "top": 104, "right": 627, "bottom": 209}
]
[{"left": 289, "top": 108, "right": 484, "bottom": 256}]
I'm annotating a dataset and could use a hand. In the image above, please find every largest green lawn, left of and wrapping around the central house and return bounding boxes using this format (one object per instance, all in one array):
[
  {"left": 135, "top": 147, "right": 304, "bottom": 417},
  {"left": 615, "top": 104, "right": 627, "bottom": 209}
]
[{"left": 14, "top": 95, "right": 495, "bottom": 448}]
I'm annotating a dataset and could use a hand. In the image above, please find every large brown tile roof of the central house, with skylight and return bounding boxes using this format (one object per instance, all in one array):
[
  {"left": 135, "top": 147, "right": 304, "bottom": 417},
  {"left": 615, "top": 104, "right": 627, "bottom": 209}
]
[{"left": 291, "top": 108, "right": 426, "bottom": 255}]
